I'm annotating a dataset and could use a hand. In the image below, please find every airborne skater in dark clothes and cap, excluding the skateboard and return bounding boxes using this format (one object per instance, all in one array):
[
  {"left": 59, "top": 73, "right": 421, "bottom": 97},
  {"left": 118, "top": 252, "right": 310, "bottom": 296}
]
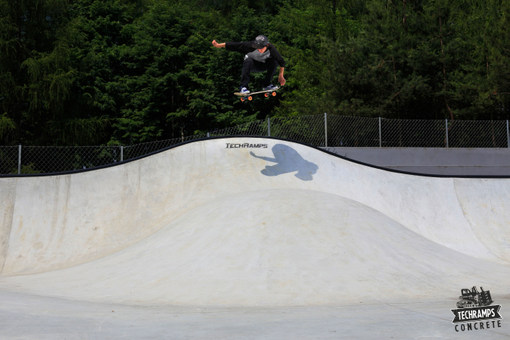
[{"left": 212, "top": 35, "right": 285, "bottom": 93}]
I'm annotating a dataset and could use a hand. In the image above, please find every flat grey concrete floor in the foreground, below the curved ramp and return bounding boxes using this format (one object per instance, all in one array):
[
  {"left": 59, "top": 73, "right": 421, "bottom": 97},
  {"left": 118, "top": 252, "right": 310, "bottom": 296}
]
[{"left": 0, "top": 291, "right": 510, "bottom": 340}]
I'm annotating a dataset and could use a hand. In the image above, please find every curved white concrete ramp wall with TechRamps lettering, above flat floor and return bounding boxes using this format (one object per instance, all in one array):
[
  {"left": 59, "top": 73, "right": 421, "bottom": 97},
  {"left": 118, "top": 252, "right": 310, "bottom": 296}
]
[{"left": 0, "top": 138, "right": 510, "bottom": 306}]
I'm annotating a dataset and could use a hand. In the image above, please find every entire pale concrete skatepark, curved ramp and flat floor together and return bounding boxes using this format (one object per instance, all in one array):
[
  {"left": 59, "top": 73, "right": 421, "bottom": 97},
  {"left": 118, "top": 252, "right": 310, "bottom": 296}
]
[{"left": 0, "top": 138, "right": 510, "bottom": 339}]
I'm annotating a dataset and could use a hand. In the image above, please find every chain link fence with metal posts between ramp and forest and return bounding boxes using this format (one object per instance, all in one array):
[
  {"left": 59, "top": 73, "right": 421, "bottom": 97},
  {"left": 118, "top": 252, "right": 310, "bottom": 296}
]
[{"left": 0, "top": 114, "right": 510, "bottom": 175}]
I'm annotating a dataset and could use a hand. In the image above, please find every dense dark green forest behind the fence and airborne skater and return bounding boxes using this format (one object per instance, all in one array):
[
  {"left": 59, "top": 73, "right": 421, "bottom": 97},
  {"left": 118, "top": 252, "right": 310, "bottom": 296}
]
[{"left": 0, "top": 0, "right": 510, "bottom": 145}]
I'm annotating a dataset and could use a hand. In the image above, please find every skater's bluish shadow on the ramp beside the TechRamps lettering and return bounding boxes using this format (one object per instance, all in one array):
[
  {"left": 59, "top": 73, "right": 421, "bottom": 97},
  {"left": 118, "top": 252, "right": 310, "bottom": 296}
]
[{"left": 250, "top": 144, "right": 319, "bottom": 181}]
